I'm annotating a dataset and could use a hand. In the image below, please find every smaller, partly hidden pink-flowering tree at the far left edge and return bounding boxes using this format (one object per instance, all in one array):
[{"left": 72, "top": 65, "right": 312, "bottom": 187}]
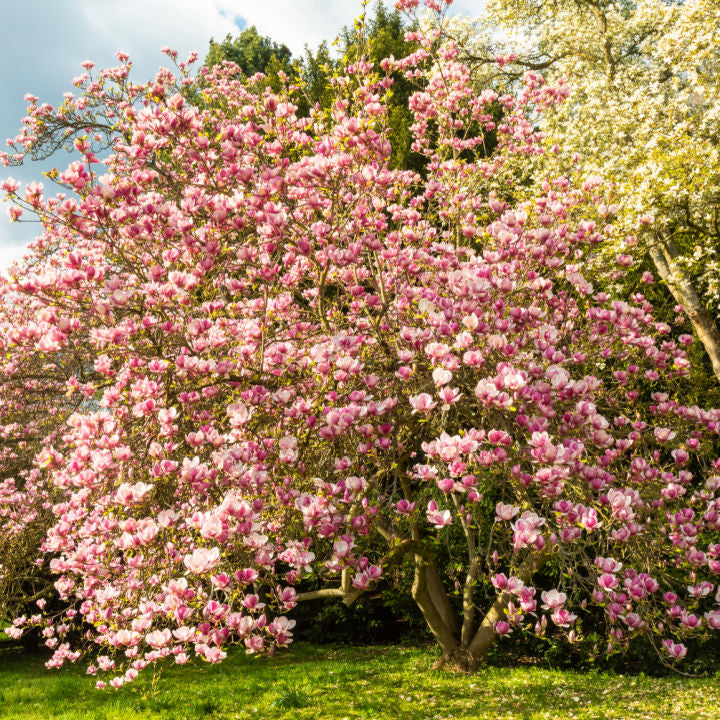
[{"left": 0, "top": 284, "right": 88, "bottom": 616}]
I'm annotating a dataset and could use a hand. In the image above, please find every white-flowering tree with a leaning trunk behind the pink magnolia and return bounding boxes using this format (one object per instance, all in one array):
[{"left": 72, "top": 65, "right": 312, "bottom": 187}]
[{"left": 450, "top": 0, "right": 720, "bottom": 378}]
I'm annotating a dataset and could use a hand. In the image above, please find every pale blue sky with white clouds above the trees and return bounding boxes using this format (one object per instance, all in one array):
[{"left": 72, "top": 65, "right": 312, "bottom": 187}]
[{"left": 0, "top": 0, "right": 483, "bottom": 269}]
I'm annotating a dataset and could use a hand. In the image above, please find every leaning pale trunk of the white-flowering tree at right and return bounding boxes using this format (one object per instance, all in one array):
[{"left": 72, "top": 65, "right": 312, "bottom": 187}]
[{"left": 649, "top": 239, "right": 720, "bottom": 380}]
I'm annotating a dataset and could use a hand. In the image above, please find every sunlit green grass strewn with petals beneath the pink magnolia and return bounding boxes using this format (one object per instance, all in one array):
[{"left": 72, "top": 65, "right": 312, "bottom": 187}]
[{"left": 0, "top": 643, "right": 720, "bottom": 720}]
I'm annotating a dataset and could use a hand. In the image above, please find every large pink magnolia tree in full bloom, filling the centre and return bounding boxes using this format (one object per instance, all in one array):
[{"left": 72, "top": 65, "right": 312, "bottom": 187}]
[{"left": 0, "top": 1, "right": 720, "bottom": 687}]
